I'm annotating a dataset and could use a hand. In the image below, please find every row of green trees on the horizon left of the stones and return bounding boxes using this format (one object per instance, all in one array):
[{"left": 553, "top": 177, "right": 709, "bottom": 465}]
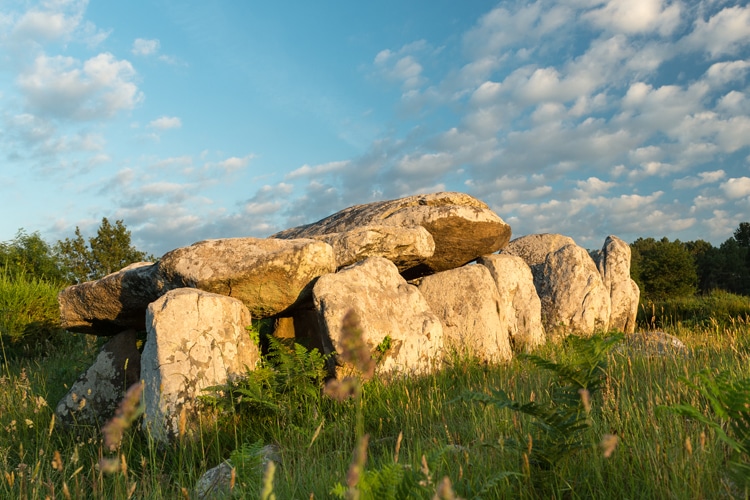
[{"left": 0, "top": 217, "right": 154, "bottom": 285}]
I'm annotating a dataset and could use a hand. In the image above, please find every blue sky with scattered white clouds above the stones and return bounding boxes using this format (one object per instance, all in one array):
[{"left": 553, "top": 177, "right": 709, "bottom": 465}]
[{"left": 0, "top": 0, "right": 750, "bottom": 256}]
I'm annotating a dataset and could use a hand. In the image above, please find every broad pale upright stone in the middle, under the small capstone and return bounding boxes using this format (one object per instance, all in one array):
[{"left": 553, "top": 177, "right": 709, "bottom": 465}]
[{"left": 313, "top": 257, "right": 443, "bottom": 373}]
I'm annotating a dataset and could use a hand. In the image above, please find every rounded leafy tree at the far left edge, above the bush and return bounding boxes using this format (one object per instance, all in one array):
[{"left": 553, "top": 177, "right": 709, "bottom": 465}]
[{"left": 0, "top": 229, "right": 65, "bottom": 282}]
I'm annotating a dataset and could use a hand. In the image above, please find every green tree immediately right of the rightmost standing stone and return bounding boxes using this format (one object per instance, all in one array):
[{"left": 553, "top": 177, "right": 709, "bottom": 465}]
[{"left": 631, "top": 238, "right": 698, "bottom": 300}]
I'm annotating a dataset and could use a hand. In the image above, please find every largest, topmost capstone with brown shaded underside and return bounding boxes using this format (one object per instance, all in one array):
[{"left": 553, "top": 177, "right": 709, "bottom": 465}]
[{"left": 272, "top": 193, "right": 510, "bottom": 278}]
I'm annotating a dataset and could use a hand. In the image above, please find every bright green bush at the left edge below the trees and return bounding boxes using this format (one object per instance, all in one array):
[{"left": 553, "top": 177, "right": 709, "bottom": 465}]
[{"left": 0, "top": 272, "right": 60, "bottom": 354}]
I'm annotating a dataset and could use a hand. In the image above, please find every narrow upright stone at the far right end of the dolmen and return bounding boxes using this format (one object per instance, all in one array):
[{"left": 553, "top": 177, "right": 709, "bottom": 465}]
[{"left": 597, "top": 235, "right": 641, "bottom": 333}]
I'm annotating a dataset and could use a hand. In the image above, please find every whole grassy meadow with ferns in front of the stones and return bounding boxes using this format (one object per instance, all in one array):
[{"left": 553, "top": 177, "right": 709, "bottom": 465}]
[{"left": 0, "top": 280, "right": 750, "bottom": 499}]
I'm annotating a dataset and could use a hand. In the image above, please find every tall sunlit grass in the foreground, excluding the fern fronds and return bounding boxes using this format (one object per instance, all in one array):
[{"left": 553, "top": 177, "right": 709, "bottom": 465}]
[{"left": 0, "top": 292, "right": 750, "bottom": 499}]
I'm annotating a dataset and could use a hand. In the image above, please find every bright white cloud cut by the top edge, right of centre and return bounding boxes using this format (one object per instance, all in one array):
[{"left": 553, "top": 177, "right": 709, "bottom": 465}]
[{"left": 583, "top": 0, "right": 681, "bottom": 35}]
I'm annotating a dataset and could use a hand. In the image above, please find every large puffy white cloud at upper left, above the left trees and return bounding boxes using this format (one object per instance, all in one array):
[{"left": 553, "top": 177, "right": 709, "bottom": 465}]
[{"left": 17, "top": 53, "right": 143, "bottom": 120}]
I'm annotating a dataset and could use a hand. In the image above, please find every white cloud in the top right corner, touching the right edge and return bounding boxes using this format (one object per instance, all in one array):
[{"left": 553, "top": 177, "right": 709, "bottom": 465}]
[{"left": 683, "top": 5, "right": 750, "bottom": 57}]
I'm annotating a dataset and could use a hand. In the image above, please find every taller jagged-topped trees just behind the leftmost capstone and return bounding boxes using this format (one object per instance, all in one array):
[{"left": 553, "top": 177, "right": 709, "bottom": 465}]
[{"left": 56, "top": 217, "right": 153, "bottom": 283}]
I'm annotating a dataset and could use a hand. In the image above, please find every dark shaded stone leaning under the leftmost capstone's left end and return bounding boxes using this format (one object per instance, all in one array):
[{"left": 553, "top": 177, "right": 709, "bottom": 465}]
[{"left": 55, "top": 330, "right": 141, "bottom": 425}]
